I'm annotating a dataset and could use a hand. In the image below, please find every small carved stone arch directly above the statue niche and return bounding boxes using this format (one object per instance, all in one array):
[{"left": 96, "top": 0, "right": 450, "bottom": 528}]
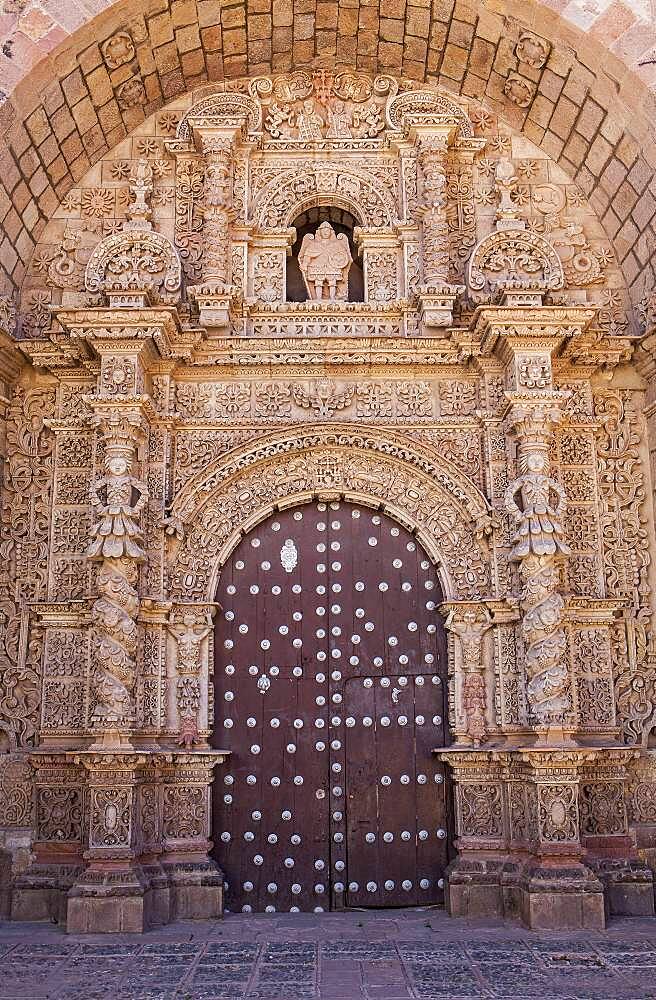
[{"left": 251, "top": 161, "right": 397, "bottom": 228}]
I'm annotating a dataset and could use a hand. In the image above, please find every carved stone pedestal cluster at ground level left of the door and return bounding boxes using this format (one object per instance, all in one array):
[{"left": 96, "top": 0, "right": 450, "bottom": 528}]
[{"left": 11, "top": 750, "right": 226, "bottom": 934}]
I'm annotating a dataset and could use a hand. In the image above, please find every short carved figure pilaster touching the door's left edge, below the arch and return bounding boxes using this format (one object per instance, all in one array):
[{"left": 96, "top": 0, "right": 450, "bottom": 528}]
[{"left": 166, "top": 603, "right": 218, "bottom": 748}]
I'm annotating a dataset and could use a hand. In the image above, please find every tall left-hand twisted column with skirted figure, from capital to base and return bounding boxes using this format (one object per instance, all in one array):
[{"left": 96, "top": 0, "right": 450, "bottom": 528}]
[{"left": 87, "top": 401, "right": 148, "bottom": 747}]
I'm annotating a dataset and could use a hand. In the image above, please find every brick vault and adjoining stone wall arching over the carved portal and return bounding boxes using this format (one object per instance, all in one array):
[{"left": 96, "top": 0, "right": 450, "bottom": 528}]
[{"left": 0, "top": 0, "right": 656, "bottom": 322}]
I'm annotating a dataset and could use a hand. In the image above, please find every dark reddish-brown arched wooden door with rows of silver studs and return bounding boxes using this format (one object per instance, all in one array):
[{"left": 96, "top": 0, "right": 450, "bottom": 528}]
[{"left": 213, "top": 501, "right": 449, "bottom": 912}]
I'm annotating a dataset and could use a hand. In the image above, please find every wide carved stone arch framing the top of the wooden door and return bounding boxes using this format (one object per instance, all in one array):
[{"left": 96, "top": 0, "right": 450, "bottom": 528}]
[{"left": 169, "top": 424, "right": 491, "bottom": 601}]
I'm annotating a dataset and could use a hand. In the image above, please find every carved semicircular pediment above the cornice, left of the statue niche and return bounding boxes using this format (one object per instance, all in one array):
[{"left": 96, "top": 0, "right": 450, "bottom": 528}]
[{"left": 84, "top": 230, "right": 182, "bottom": 307}]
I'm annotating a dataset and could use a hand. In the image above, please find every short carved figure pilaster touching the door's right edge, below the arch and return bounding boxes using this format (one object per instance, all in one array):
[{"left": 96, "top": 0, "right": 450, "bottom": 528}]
[{"left": 443, "top": 605, "right": 492, "bottom": 747}]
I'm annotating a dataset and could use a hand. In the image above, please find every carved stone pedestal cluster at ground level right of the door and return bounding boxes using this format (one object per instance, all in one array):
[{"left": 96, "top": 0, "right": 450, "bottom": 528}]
[{"left": 440, "top": 746, "right": 640, "bottom": 930}]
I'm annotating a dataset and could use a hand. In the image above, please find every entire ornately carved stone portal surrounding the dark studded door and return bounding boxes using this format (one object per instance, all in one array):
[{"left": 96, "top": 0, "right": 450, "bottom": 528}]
[{"left": 0, "top": 70, "right": 656, "bottom": 931}]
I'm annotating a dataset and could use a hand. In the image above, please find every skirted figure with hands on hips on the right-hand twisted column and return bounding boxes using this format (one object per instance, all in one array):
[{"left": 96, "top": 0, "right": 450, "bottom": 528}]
[{"left": 505, "top": 453, "right": 570, "bottom": 559}]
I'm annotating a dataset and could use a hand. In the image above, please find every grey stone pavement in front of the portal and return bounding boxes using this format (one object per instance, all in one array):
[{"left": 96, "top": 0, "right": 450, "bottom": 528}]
[{"left": 0, "top": 910, "right": 656, "bottom": 1000}]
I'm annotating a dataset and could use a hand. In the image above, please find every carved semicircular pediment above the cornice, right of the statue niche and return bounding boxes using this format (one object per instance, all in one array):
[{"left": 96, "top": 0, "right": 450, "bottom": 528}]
[{"left": 467, "top": 228, "right": 565, "bottom": 303}]
